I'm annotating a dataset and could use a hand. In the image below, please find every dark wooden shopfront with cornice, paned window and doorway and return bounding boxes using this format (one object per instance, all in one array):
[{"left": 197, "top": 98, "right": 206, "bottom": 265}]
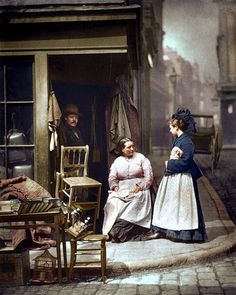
[{"left": 0, "top": 0, "right": 162, "bottom": 202}]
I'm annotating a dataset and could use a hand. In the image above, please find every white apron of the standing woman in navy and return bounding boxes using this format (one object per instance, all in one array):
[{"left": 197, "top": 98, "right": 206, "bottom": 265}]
[{"left": 152, "top": 173, "right": 198, "bottom": 231}]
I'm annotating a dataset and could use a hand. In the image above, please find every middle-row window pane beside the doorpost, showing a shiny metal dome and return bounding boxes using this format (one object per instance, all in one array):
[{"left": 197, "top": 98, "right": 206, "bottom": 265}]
[{"left": 7, "top": 104, "right": 34, "bottom": 145}]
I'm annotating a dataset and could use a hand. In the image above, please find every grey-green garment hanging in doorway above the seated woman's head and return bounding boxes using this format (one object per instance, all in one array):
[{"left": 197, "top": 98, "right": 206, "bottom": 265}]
[{"left": 109, "top": 94, "right": 131, "bottom": 155}]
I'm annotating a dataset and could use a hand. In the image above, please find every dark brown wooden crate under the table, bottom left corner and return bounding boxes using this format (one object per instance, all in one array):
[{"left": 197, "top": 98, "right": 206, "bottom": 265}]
[{"left": 0, "top": 250, "right": 30, "bottom": 287}]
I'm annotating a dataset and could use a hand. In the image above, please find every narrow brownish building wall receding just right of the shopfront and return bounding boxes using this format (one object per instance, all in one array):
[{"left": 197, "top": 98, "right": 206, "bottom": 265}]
[{"left": 139, "top": 0, "right": 164, "bottom": 154}]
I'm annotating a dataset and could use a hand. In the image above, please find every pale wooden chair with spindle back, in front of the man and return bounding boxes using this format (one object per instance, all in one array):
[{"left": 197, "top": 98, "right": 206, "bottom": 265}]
[{"left": 55, "top": 145, "right": 102, "bottom": 232}]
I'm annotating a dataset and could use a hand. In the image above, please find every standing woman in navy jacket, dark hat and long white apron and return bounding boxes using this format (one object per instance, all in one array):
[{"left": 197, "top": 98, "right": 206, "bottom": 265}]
[{"left": 152, "top": 108, "right": 207, "bottom": 242}]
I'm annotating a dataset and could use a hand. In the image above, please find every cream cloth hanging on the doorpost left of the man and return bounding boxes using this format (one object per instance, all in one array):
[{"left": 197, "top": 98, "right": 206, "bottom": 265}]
[{"left": 48, "top": 91, "right": 61, "bottom": 151}]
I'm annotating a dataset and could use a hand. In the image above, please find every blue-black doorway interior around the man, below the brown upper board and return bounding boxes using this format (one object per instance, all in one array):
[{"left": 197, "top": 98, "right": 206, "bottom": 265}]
[{"left": 52, "top": 81, "right": 111, "bottom": 181}]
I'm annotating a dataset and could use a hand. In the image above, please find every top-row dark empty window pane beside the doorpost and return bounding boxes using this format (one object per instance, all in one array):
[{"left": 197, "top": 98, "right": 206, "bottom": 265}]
[{"left": 6, "top": 60, "right": 33, "bottom": 100}]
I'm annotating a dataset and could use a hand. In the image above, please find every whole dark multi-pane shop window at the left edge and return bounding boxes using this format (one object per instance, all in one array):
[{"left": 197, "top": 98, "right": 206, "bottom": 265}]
[{"left": 0, "top": 57, "right": 34, "bottom": 178}]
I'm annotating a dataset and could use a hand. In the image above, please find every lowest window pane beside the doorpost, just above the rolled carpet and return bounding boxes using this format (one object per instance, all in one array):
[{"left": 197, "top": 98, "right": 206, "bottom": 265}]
[{"left": 8, "top": 148, "right": 34, "bottom": 178}]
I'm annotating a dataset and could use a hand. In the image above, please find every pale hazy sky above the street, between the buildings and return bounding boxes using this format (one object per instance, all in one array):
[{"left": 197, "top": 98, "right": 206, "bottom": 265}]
[{"left": 163, "top": 0, "right": 219, "bottom": 81}]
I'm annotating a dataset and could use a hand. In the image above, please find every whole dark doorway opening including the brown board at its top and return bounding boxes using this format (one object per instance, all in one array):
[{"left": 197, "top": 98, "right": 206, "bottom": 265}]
[{"left": 49, "top": 54, "right": 127, "bottom": 231}]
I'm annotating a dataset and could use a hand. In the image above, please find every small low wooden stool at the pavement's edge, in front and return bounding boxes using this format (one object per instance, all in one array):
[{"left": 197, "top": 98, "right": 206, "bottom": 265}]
[{"left": 69, "top": 234, "right": 107, "bottom": 283}]
